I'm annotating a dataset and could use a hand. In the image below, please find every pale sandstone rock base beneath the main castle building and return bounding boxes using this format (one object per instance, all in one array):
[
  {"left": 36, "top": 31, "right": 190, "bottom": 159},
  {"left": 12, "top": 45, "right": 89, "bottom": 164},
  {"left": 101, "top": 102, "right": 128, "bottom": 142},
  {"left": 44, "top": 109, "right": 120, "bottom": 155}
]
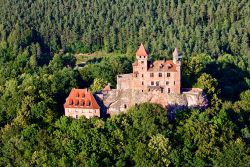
[{"left": 97, "top": 88, "right": 208, "bottom": 115}]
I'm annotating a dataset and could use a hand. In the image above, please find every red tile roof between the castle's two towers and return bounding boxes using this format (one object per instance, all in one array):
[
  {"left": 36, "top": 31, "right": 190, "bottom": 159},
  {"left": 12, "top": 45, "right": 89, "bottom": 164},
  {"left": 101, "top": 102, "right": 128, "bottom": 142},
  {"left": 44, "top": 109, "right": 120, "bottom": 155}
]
[{"left": 148, "top": 60, "right": 176, "bottom": 72}]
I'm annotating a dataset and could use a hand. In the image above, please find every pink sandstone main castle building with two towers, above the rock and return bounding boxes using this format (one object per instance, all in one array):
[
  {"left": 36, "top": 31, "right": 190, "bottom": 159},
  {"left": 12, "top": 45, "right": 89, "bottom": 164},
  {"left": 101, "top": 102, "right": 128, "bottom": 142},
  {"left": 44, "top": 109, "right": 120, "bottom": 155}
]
[{"left": 117, "top": 44, "right": 182, "bottom": 94}]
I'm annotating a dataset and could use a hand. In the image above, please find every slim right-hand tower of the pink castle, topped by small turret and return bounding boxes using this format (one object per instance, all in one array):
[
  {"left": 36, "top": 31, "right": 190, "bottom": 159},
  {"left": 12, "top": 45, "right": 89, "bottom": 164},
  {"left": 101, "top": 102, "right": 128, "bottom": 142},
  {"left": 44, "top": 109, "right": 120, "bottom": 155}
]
[{"left": 173, "top": 48, "right": 182, "bottom": 94}]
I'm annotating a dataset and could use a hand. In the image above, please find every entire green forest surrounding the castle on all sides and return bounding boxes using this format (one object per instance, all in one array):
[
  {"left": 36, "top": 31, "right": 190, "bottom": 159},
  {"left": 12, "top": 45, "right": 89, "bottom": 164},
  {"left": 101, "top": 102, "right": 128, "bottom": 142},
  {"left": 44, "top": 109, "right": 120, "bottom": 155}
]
[{"left": 0, "top": 0, "right": 250, "bottom": 167}]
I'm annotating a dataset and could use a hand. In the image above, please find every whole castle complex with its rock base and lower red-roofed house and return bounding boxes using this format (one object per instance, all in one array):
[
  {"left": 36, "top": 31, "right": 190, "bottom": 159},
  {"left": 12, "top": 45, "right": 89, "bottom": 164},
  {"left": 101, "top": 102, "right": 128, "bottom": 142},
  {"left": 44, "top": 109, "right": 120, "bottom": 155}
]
[{"left": 64, "top": 44, "right": 208, "bottom": 118}]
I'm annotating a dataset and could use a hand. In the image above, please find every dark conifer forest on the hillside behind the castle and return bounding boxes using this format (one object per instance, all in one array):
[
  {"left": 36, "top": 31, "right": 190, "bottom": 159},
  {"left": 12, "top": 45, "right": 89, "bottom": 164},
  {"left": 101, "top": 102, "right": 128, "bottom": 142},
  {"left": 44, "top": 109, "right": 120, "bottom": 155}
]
[{"left": 0, "top": 0, "right": 250, "bottom": 56}]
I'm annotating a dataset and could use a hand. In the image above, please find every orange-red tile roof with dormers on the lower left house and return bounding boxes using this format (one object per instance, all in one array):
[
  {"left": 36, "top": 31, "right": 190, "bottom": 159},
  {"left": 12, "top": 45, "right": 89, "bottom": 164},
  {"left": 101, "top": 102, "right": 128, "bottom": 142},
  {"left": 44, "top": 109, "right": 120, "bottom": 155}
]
[{"left": 64, "top": 89, "right": 100, "bottom": 109}]
